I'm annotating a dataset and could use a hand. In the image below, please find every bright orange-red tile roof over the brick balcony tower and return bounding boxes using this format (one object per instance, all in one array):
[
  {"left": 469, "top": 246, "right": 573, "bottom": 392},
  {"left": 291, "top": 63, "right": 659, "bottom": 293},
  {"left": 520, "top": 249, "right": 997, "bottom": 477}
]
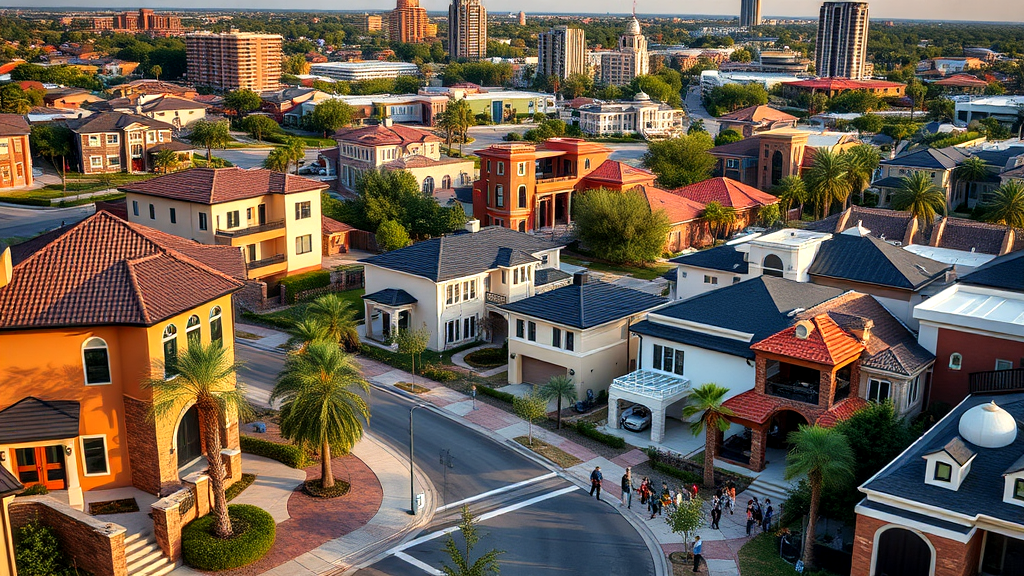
[{"left": 751, "top": 314, "right": 864, "bottom": 366}]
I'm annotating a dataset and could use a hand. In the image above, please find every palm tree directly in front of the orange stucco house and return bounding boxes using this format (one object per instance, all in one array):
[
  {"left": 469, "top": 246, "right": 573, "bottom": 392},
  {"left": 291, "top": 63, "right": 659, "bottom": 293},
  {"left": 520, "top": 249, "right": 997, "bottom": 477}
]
[{"left": 142, "top": 342, "right": 251, "bottom": 538}]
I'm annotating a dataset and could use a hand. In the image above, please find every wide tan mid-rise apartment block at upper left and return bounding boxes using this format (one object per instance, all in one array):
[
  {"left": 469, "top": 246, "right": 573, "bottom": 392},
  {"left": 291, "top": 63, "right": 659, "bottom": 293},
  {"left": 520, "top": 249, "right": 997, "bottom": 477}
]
[{"left": 185, "top": 30, "right": 283, "bottom": 92}]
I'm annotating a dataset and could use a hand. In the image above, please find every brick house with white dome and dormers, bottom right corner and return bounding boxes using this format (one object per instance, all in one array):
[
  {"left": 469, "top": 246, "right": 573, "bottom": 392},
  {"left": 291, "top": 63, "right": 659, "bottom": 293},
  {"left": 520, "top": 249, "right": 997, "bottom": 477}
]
[{"left": 850, "top": 387, "right": 1024, "bottom": 576}]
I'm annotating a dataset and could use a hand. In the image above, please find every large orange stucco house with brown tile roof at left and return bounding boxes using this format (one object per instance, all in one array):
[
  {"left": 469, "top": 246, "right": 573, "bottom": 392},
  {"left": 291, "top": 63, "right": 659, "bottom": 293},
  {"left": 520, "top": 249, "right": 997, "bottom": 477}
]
[{"left": 0, "top": 211, "right": 246, "bottom": 508}]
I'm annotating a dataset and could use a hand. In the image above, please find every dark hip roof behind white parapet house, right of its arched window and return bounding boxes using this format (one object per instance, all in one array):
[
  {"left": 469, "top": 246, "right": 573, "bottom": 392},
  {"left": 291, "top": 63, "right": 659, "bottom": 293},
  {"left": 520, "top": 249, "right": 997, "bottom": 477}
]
[{"left": 808, "top": 234, "right": 952, "bottom": 290}]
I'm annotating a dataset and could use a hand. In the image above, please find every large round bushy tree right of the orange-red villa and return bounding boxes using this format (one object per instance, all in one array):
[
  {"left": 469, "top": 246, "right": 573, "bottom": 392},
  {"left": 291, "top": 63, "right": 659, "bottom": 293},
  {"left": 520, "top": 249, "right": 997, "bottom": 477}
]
[{"left": 573, "top": 189, "right": 672, "bottom": 264}]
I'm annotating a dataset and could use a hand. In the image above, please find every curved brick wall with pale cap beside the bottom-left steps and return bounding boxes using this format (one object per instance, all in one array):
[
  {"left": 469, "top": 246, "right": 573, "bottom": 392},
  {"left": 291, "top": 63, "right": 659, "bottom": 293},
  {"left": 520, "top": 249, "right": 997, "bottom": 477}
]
[{"left": 10, "top": 496, "right": 128, "bottom": 576}]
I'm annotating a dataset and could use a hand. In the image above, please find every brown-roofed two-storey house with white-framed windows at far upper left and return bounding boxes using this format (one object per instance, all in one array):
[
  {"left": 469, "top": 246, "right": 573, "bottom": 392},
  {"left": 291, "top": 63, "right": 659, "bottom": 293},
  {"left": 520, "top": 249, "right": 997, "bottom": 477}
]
[{"left": 68, "top": 112, "right": 174, "bottom": 174}]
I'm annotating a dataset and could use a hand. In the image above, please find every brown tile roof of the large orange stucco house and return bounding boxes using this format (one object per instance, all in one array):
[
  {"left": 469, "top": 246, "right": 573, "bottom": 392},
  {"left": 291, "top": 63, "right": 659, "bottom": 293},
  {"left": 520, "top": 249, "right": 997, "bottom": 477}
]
[{"left": 0, "top": 211, "right": 244, "bottom": 329}]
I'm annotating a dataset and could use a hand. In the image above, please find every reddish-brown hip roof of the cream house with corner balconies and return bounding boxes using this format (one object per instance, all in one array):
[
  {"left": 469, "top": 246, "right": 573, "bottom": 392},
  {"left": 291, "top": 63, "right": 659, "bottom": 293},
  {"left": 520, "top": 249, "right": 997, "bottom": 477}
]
[{"left": 119, "top": 167, "right": 328, "bottom": 204}]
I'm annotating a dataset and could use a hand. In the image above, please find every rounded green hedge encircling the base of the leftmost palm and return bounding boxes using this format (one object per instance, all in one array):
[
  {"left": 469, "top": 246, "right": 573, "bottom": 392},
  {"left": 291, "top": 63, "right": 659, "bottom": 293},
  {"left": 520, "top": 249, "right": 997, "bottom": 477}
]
[{"left": 181, "top": 504, "right": 276, "bottom": 570}]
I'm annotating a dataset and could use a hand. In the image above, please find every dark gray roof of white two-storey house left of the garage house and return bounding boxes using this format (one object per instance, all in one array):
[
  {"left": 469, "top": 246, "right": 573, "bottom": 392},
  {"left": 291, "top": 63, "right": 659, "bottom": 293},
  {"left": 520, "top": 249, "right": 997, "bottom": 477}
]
[{"left": 359, "top": 227, "right": 563, "bottom": 282}]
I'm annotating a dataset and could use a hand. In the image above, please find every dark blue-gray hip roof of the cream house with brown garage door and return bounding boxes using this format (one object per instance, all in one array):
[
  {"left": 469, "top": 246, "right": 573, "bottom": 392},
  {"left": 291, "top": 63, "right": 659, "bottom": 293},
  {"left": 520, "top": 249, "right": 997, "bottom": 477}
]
[{"left": 501, "top": 282, "right": 669, "bottom": 329}]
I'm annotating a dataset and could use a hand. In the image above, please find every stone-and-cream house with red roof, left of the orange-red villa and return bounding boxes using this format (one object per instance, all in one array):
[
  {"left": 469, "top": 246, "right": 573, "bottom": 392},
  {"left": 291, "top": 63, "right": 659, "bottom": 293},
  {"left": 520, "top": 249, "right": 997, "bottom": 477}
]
[{"left": 335, "top": 122, "right": 475, "bottom": 194}]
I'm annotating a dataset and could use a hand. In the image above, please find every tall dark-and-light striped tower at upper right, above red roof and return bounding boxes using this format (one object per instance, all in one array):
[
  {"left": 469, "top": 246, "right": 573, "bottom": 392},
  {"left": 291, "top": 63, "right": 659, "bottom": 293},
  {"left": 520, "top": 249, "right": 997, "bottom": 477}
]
[{"left": 814, "top": 2, "right": 867, "bottom": 80}]
